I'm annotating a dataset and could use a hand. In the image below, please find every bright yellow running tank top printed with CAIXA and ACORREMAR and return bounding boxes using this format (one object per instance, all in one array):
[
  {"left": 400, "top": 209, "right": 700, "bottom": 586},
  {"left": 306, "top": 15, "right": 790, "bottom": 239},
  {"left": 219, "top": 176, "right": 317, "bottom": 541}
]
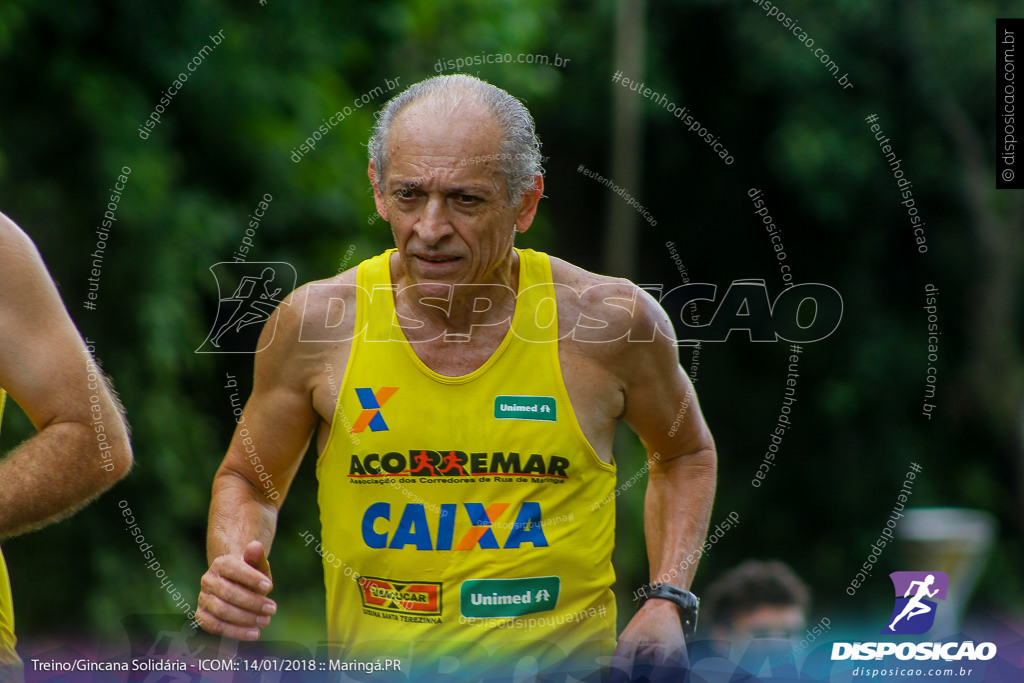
[{"left": 316, "top": 249, "right": 615, "bottom": 678}]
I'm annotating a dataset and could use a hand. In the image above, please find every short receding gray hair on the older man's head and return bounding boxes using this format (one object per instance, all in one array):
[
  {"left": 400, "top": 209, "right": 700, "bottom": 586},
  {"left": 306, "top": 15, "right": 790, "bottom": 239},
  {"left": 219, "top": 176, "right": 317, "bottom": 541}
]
[{"left": 368, "top": 74, "right": 544, "bottom": 203}]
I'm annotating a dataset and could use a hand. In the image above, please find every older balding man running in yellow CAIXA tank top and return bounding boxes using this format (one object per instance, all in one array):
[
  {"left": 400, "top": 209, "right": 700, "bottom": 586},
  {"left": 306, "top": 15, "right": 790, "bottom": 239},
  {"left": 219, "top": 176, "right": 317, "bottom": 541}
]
[{"left": 199, "top": 75, "right": 716, "bottom": 678}]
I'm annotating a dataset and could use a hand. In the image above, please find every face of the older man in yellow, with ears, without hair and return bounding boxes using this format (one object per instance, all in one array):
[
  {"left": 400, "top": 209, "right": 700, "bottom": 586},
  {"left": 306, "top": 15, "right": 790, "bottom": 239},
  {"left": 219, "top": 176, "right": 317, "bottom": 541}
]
[{"left": 370, "top": 102, "right": 543, "bottom": 297}]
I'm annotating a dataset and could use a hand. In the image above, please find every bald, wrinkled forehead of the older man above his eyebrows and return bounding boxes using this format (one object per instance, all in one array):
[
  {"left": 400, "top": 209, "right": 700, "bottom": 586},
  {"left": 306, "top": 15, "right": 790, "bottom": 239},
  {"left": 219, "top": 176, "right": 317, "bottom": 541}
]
[{"left": 383, "top": 98, "right": 504, "bottom": 184}]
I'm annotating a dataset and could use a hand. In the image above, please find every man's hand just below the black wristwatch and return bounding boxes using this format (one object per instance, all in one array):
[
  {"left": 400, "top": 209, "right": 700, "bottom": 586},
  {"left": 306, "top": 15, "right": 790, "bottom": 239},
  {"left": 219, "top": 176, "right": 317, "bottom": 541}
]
[{"left": 611, "top": 598, "right": 689, "bottom": 680}]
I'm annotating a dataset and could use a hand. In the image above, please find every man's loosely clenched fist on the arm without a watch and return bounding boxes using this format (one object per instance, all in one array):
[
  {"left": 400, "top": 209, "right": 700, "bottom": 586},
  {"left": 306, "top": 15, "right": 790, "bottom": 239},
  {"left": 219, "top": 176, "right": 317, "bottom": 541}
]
[{"left": 196, "top": 541, "right": 278, "bottom": 640}]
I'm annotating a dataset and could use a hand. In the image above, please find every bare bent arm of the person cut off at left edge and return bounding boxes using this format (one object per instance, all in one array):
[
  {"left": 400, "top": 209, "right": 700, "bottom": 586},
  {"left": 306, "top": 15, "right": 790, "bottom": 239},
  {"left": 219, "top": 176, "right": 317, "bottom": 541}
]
[{"left": 0, "top": 213, "right": 132, "bottom": 538}]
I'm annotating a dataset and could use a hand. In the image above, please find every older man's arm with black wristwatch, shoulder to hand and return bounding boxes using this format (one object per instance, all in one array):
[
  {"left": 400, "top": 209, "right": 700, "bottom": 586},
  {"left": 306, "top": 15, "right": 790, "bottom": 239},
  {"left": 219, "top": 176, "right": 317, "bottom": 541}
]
[{"left": 620, "top": 286, "right": 717, "bottom": 661}]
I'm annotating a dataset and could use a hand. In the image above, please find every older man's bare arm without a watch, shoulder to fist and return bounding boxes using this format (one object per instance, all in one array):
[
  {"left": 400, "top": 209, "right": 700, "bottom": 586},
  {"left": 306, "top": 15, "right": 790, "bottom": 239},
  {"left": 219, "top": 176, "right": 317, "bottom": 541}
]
[{"left": 197, "top": 288, "right": 337, "bottom": 640}]
